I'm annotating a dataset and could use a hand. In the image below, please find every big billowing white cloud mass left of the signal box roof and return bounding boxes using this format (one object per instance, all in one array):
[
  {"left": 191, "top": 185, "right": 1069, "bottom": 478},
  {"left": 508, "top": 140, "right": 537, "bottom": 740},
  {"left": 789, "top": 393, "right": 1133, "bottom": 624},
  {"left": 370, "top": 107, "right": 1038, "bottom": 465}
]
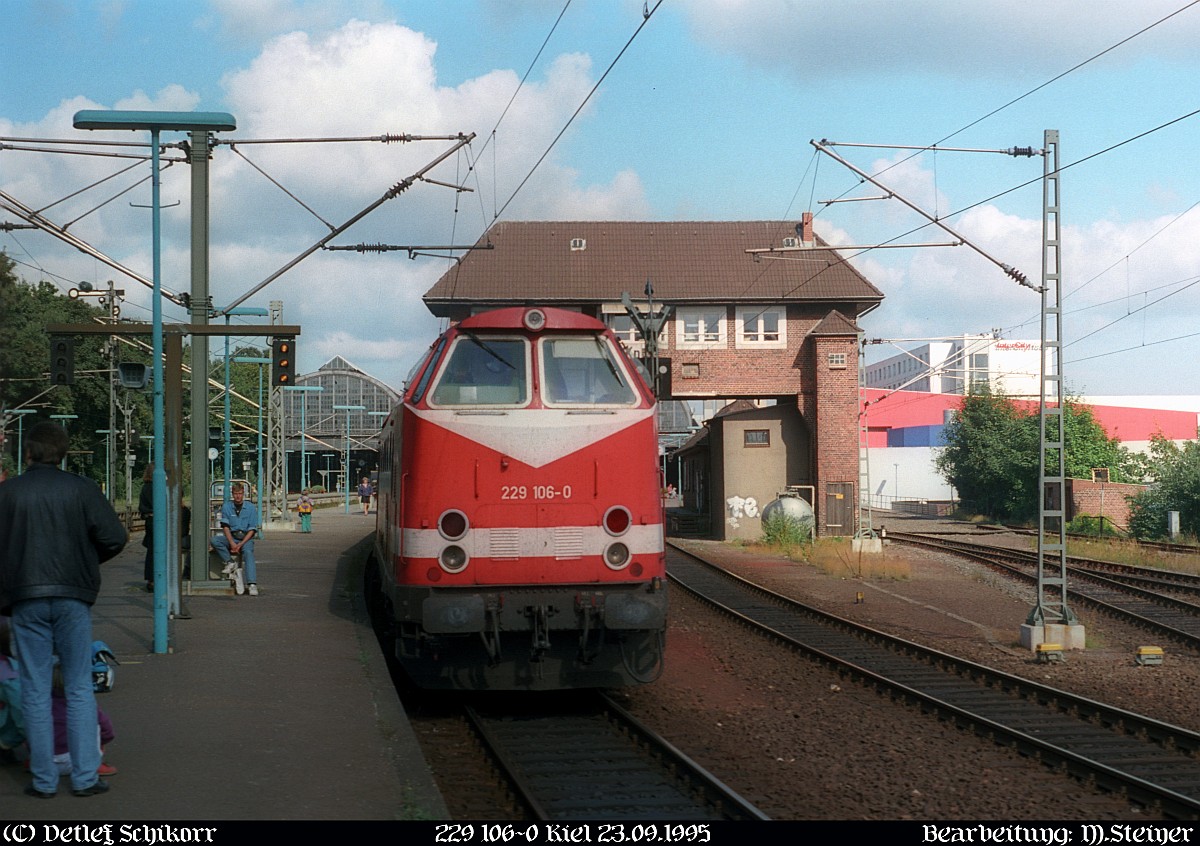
[{"left": 0, "top": 18, "right": 648, "bottom": 386}]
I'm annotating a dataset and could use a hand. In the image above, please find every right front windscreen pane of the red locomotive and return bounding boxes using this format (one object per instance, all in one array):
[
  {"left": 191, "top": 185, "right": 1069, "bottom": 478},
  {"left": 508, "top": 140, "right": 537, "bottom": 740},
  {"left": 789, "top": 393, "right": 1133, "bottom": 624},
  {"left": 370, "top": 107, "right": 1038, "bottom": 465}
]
[{"left": 539, "top": 337, "right": 637, "bottom": 406}]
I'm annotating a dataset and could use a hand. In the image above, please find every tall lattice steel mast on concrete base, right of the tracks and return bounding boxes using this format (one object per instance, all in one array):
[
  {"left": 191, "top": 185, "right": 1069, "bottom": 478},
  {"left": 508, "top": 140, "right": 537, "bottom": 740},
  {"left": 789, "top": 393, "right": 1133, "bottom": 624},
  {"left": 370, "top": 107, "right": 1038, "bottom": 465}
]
[{"left": 1026, "top": 130, "right": 1078, "bottom": 625}]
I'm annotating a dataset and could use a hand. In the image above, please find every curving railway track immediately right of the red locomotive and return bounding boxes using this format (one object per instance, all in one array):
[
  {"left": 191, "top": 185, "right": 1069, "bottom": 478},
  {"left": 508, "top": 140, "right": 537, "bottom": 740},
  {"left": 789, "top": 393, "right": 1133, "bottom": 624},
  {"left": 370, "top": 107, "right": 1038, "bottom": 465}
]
[{"left": 668, "top": 548, "right": 1200, "bottom": 820}]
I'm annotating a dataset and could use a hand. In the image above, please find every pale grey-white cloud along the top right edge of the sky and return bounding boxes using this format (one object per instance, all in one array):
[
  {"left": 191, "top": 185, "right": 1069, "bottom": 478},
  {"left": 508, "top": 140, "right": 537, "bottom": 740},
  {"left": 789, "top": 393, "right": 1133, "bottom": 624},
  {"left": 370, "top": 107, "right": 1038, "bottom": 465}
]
[{"left": 682, "top": 0, "right": 1200, "bottom": 79}]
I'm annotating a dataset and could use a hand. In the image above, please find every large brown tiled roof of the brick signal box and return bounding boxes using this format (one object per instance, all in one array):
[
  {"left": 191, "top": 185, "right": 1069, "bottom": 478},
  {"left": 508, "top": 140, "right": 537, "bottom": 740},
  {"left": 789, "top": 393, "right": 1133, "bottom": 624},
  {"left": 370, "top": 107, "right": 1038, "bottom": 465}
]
[{"left": 425, "top": 221, "right": 883, "bottom": 313}]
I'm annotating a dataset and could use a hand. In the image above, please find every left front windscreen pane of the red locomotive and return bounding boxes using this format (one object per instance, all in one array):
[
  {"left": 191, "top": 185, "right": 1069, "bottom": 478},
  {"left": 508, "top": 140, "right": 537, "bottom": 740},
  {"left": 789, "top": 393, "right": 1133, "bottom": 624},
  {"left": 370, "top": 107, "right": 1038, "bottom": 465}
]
[{"left": 430, "top": 332, "right": 529, "bottom": 406}]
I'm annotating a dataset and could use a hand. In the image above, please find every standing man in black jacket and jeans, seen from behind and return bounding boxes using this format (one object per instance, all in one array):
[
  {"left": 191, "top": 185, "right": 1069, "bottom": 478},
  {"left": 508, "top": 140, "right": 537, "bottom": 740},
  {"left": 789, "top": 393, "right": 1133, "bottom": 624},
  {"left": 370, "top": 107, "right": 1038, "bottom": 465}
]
[{"left": 0, "top": 422, "right": 127, "bottom": 799}]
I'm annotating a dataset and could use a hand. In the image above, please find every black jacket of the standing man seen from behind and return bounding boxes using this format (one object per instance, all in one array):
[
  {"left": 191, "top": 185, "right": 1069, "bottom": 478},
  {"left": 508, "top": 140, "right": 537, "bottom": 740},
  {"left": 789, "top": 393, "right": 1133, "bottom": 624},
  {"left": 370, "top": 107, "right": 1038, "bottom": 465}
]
[{"left": 0, "top": 464, "right": 128, "bottom": 613}]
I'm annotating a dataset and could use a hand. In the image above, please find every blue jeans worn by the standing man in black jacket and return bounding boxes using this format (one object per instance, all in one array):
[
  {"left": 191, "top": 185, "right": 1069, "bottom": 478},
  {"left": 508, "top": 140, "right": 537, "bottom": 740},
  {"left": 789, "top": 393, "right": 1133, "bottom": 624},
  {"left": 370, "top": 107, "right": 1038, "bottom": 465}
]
[{"left": 12, "top": 596, "right": 100, "bottom": 793}]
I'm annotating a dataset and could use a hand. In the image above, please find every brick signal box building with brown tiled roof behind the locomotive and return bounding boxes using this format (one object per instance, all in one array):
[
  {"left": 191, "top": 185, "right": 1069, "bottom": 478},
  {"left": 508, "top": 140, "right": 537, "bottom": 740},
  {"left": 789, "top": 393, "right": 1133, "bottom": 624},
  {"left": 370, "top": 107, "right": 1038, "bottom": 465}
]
[{"left": 424, "top": 215, "right": 883, "bottom": 538}]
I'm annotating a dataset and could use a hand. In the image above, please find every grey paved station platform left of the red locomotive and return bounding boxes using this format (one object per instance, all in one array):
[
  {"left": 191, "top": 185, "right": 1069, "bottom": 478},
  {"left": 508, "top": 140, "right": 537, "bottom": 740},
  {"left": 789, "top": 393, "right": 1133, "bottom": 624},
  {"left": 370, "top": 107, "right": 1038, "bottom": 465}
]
[{"left": 0, "top": 503, "right": 450, "bottom": 823}]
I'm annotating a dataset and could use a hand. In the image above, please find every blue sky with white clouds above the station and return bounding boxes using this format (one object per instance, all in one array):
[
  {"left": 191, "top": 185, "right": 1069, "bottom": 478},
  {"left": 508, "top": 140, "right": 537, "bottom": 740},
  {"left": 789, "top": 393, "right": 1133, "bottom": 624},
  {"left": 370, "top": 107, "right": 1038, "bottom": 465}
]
[{"left": 0, "top": 0, "right": 1200, "bottom": 396}]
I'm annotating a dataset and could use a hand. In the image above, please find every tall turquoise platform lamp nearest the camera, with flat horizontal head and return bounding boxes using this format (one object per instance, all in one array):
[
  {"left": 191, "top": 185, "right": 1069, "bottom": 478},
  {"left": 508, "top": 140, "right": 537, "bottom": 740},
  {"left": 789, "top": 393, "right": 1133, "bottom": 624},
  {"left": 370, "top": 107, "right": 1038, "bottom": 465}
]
[{"left": 74, "top": 109, "right": 238, "bottom": 654}]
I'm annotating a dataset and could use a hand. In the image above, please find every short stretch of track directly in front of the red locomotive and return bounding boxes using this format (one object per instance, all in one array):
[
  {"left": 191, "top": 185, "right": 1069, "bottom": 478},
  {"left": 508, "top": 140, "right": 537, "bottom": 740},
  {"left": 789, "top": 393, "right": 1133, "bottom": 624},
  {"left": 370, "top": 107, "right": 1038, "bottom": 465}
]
[{"left": 467, "top": 695, "right": 769, "bottom": 822}]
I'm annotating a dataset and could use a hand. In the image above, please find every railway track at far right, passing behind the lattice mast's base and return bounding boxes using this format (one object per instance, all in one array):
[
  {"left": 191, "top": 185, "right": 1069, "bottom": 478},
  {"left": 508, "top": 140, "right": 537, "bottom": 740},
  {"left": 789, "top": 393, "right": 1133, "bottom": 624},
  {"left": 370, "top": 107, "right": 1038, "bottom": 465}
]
[{"left": 888, "top": 532, "right": 1200, "bottom": 652}]
